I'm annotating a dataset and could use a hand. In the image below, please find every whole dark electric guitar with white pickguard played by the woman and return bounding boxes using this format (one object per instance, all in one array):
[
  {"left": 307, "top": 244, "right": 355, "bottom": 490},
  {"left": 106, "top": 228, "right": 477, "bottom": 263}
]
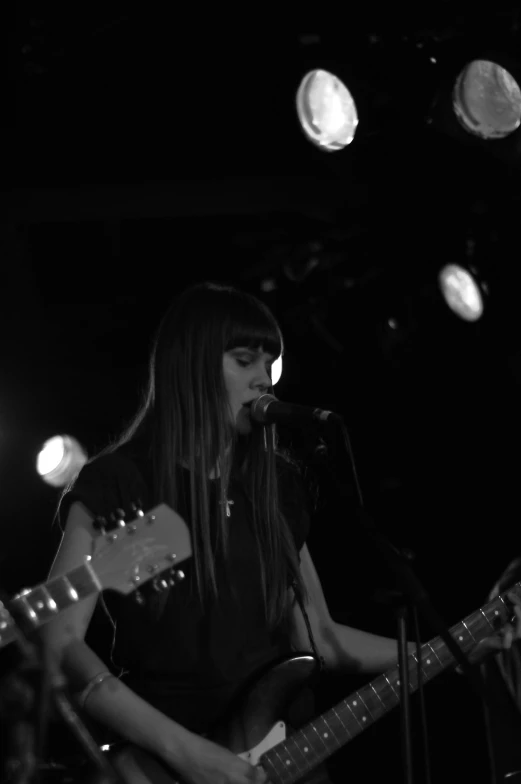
[{"left": 106, "top": 582, "right": 521, "bottom": 784}]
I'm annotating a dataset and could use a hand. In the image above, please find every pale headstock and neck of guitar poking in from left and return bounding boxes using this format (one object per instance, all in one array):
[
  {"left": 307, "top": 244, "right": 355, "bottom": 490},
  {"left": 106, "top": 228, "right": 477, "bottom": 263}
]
[{"left": 0, "top": 504, "right": 192, "bottom": 648}]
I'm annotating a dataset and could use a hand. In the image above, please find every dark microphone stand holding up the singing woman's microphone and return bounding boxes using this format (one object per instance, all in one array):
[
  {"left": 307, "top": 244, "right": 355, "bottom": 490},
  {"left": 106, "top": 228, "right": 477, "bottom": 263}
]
[{"left": 324, "top": 415, "right": 494, "bottom": 784}]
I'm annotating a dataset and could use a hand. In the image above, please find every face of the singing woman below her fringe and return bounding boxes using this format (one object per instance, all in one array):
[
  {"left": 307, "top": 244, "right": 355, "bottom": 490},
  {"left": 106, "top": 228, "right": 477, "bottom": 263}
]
[{"left": 223, "top": 347, "right": 275, "bottom": 435}]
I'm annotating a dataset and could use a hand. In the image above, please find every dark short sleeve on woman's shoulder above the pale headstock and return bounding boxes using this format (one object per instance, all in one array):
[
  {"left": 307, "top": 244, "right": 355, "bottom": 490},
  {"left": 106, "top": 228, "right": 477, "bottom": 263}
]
[{"left": 58, "top": 452, "right": 149, "bottom": 528}]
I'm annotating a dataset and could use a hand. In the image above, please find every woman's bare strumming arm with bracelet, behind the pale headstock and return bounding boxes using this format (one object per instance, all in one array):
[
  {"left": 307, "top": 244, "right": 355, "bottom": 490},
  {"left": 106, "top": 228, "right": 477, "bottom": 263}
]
[{"left": 42, "top": 503, "right": 267, "bottom": 784}]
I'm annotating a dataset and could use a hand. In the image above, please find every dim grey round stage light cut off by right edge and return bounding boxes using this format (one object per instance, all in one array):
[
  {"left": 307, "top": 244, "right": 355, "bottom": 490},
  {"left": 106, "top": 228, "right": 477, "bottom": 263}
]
[{"left": 452, "top": 60, "right": 521, "bottom": 139}]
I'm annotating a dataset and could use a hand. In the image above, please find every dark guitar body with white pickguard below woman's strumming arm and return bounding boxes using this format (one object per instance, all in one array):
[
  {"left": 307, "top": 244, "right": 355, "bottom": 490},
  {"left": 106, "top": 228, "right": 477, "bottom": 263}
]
[{"left": 106, "top": 654, "right": 317, "bottom": 784}]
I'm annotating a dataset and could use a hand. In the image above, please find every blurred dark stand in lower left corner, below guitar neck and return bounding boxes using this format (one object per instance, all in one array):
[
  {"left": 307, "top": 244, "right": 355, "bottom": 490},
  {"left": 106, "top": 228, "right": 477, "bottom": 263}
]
[{"left": 0, "top": 592, "right": 123, "bottom": 784}]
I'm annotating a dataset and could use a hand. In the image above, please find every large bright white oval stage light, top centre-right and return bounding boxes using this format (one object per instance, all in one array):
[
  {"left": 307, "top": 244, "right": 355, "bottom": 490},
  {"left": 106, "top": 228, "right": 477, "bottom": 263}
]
[{"left": 297, "top": 70, "right": 358, "bottom": 150}]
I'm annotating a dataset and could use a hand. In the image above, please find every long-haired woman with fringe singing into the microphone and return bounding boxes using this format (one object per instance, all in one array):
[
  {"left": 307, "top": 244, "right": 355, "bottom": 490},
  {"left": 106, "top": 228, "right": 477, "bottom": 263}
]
[{"left": 44, "top": 283, "right": 520, "bottom": 784}]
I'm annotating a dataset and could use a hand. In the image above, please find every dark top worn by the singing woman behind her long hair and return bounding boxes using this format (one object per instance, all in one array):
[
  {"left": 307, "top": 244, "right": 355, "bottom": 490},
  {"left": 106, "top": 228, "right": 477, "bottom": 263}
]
[{"left": 60, "top": 443, "right": 310, "bottom": 734}]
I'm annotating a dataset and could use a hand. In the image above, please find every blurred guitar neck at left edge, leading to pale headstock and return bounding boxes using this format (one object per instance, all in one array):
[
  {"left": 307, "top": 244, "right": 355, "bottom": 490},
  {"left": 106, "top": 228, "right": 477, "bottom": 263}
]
[{"left": 0, "top": 563, "right": 98, "bottom": 648}]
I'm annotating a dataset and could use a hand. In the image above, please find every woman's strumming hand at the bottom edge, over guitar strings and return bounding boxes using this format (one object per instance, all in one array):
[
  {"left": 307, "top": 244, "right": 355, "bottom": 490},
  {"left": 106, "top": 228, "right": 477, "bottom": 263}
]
[{"left": 174, "top": 736, "right": 268, "bottom": 784}]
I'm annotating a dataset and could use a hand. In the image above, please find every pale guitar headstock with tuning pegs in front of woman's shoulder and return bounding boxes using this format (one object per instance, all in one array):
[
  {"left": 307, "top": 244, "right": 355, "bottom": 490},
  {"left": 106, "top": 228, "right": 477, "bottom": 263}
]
[{"left": 89, "top": 504, "right": 192, "bottom": 594}]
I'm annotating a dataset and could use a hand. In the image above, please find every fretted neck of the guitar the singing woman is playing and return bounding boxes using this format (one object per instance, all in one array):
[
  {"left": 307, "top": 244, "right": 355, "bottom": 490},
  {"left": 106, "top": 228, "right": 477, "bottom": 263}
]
[{"left": 260, "top": 582, "right": 521, "bottom": 784}]
